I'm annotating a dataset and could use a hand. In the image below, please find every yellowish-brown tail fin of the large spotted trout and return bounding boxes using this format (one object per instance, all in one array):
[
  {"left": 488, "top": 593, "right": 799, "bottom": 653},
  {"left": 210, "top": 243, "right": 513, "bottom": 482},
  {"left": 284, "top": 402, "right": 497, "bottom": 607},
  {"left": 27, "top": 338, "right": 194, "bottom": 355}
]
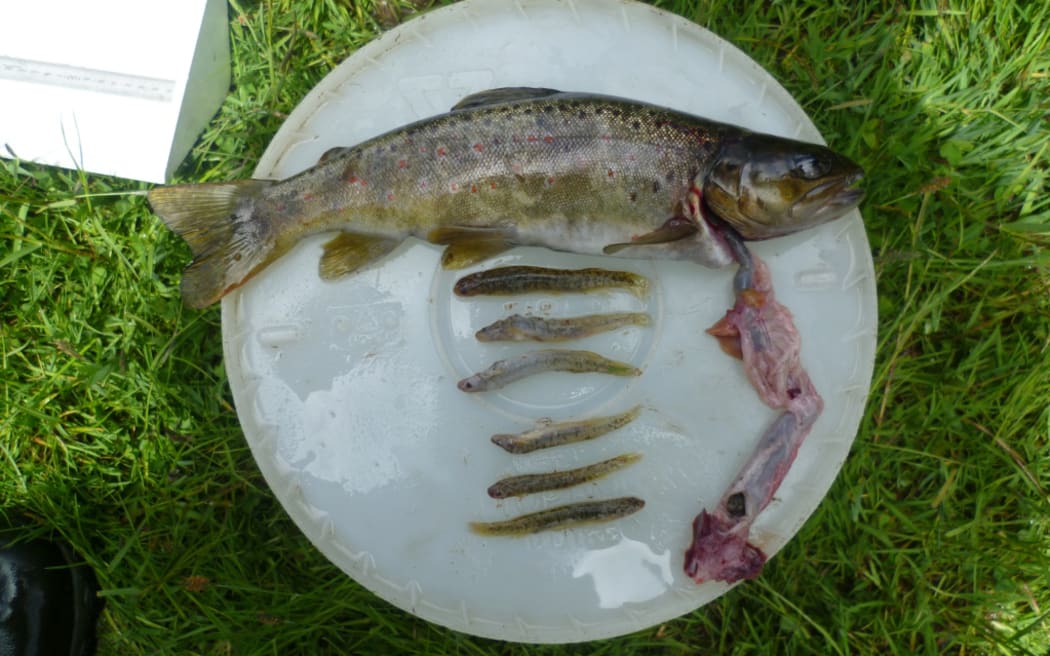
[{"left": 147, "top": 179, "right": 277, "bottom": 309}]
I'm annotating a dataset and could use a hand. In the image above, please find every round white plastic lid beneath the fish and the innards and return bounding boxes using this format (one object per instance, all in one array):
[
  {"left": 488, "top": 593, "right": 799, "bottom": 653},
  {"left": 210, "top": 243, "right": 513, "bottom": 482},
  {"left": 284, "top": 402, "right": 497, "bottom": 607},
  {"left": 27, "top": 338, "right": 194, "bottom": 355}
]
[{"left": 223, "top": 0, "right": 876, "bottom": 642}]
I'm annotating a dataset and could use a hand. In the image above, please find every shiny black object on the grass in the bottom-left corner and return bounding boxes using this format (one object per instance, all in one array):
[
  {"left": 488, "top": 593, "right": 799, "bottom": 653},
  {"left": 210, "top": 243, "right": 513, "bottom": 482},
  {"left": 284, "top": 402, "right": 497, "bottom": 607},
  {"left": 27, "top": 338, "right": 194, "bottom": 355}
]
[{"left": 0, "top": 538, "right": 103, "bottom": 656}]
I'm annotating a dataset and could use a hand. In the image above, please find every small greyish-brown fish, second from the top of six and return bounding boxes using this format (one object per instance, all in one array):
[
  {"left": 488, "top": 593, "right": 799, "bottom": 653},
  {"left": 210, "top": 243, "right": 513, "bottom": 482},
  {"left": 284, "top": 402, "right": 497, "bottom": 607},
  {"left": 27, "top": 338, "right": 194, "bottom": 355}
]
[{"left": 474, "top": 312, "right": 652, "bottom": 342}]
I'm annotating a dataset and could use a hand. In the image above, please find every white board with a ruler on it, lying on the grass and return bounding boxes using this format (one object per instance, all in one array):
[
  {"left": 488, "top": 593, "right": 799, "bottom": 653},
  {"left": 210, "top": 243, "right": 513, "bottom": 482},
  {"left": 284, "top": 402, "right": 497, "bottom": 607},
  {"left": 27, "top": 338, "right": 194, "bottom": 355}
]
[{"left": 0, "top": 0, "right": 230, "bottom": 183}]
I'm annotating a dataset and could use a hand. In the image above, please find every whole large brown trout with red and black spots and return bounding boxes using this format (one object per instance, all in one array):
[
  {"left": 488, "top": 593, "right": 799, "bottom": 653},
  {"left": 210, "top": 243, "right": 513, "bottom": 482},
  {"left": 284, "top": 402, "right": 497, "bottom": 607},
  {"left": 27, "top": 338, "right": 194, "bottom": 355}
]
[{"left": 148, "top": 88, "right": 863, "bottom": 308}]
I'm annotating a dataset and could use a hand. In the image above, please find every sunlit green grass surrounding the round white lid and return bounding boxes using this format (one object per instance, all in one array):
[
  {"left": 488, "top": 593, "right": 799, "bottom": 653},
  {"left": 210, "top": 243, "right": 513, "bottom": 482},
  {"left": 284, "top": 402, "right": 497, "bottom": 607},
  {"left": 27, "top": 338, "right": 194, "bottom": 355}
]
[{"left": 0, "top": 0, "right": 1050, "bottom": 656}]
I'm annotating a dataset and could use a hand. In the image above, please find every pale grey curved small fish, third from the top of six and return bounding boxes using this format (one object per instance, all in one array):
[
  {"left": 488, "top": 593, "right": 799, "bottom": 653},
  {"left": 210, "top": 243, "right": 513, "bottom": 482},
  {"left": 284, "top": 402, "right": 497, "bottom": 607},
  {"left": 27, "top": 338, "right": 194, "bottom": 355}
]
[{"left": 458, "top": 348, "right": 642, "bottom": 392}]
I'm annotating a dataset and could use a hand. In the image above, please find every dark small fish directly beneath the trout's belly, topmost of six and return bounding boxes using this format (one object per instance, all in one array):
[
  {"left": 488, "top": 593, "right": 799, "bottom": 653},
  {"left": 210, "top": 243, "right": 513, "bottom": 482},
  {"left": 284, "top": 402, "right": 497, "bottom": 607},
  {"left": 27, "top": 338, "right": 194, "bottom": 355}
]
[{"left": 453, "top": 267, "right": 649, "bottom": 298}]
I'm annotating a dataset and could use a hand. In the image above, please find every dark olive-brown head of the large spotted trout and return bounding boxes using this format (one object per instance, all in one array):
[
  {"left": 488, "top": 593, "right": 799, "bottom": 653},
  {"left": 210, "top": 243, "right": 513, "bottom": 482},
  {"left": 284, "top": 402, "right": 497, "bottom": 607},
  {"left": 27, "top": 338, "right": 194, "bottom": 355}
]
[{"left": 702, "top": 132, "right": 864, "bottom": 240}]
